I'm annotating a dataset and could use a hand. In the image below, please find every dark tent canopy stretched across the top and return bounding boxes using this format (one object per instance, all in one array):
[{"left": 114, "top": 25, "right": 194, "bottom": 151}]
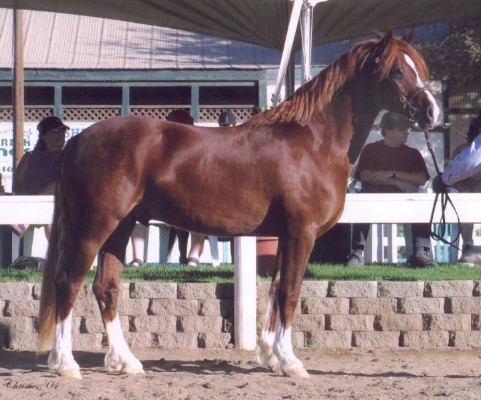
[{"left": 0, "top": 0, "right": 481, "bottom": 50}]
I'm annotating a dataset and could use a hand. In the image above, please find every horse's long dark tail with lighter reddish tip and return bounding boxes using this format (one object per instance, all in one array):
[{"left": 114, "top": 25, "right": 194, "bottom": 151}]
[{"left": 38, "top": 163, "right": 70, "bottom": 352}]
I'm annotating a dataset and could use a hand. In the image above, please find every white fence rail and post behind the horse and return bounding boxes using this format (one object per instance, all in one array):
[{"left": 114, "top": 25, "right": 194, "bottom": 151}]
[{"left": 0, "top": 193, "right": 481, "bottom": 349}]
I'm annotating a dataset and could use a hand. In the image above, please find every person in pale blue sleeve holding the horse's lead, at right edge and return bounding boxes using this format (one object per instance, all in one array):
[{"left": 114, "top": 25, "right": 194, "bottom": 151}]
[{"left": 433, "top": 113, "right": 481, "bottom": 266}]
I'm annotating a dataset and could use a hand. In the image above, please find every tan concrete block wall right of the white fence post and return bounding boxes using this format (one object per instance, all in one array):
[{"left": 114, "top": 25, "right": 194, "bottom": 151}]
[{"left": 258, "top": 281, "right": 481, "bottom": 349}]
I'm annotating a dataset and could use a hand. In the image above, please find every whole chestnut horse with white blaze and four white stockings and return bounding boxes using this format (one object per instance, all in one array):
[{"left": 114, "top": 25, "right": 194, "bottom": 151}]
[{"left": 39, "top": 31, "right": 439, "bottom": 378}]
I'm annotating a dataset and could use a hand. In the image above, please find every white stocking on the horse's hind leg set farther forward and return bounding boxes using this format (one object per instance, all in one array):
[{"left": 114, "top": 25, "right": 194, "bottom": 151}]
[{"left": 105, "top": 315, "right": 144, "bottom": 374}]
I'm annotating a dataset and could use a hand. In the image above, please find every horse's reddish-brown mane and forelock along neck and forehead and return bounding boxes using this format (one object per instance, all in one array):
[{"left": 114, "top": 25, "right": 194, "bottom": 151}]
[{"left": 246, "top": 37, "right": 428, "bottom": 127}]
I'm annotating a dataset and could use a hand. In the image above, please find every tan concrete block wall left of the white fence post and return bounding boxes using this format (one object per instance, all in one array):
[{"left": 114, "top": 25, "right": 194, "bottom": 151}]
[{"left": 0, "top": 282, "right": 234, "bottom": 351}]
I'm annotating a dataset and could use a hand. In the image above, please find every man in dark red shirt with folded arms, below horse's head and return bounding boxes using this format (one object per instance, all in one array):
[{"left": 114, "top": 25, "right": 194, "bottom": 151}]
[{"left": 346, "top": 112, "right": 436, "bottom": 268}]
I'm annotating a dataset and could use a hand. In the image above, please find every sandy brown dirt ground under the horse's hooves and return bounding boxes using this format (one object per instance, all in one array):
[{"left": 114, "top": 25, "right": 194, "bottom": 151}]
[{"left": 0, "top": 349, "right": 481, "bottom": 400}]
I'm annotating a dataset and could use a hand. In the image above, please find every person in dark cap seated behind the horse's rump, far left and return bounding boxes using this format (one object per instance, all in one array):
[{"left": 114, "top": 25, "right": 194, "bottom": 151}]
[{"left": 13, "top": 116, "right": 70, "bottom": 239}]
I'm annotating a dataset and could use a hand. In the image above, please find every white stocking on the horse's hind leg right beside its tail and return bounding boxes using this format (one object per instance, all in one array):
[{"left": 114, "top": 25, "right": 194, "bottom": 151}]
[{"left": 48, "top": 312, "right": 82, "bottom": 379}]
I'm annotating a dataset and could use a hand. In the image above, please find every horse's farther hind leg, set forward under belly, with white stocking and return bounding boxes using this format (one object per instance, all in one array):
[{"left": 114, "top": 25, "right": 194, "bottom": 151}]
[{"left": 93, "top": 216, "right": 144, "bottom": 374}]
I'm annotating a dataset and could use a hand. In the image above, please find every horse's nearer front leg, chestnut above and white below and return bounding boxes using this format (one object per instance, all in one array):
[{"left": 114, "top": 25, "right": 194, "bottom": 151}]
[{"left": 273, "top": 234, "right": 314, "bottom": 378}]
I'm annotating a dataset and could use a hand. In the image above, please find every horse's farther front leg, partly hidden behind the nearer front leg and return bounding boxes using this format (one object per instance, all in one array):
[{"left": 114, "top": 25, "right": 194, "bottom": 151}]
[{"left": 257, "top": 240, "right": 283, "bottom": 372}]
